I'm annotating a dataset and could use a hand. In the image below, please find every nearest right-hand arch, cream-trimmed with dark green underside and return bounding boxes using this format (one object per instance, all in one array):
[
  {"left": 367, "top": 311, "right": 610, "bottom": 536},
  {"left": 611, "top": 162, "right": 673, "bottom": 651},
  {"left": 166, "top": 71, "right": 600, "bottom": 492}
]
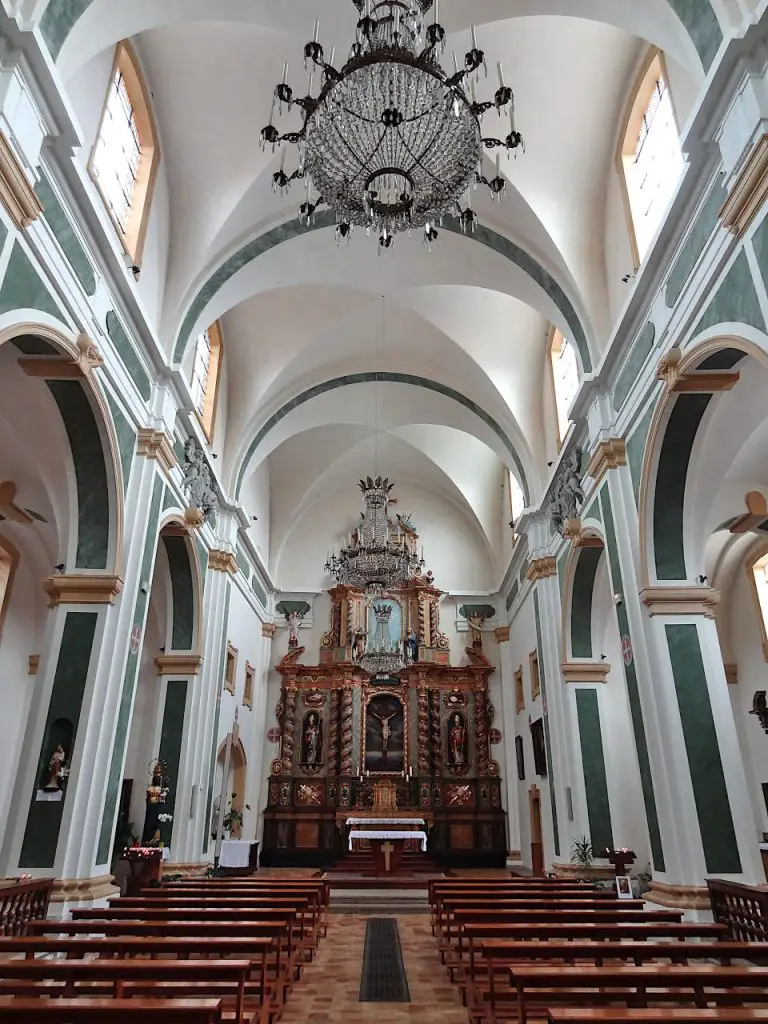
[{"left": 638, "top": 334, "right": 768, "bottom": 587}]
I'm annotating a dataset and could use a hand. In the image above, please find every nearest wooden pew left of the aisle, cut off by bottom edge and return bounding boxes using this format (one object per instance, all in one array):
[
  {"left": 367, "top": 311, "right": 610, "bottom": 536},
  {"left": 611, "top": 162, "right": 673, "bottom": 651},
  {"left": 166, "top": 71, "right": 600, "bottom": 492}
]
[{"left": 0, "top": 996, "right": 221, "bottom": 1024}]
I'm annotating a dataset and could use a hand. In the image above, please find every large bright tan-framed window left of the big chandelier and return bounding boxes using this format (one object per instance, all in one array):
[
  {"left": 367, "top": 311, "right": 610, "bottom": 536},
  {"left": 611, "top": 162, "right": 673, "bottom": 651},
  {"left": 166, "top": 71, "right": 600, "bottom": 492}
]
[{"left": 89, "top": 41, "right": 160, "bottom": 266}]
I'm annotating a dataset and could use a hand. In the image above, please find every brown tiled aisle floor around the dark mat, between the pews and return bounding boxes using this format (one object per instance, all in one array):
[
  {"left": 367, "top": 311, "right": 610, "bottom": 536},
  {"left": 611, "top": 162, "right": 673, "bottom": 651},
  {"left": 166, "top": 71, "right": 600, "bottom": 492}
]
[{"left": 281, "top": 914, "right": 467, "bottom": 1024}]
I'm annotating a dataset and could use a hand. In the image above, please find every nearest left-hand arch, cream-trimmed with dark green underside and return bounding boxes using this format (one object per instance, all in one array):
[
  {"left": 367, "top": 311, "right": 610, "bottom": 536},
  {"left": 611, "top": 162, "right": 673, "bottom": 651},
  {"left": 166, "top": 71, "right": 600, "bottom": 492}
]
[{"left": 0, "top": 321, "right": 125, "bottom": 575}]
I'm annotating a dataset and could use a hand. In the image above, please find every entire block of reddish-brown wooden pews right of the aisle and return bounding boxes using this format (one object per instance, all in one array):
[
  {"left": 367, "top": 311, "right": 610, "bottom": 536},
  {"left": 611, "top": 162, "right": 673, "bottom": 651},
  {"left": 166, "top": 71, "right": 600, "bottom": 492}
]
[{"left": 429, "top": 878, "right": 768, "bottom": 1024}]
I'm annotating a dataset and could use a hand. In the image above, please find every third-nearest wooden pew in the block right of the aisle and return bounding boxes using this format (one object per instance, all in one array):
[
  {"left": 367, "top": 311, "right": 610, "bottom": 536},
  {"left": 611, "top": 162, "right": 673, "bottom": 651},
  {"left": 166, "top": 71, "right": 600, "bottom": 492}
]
[{"left": 459, "top": 936, "right": 768, "bottom": 1019}]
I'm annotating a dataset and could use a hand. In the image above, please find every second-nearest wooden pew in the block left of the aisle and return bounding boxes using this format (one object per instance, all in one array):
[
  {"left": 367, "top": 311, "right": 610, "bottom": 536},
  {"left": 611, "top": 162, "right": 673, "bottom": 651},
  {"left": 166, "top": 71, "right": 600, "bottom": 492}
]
[{"left": 0, "top": 958, "right": 252, "bottom": 1024}]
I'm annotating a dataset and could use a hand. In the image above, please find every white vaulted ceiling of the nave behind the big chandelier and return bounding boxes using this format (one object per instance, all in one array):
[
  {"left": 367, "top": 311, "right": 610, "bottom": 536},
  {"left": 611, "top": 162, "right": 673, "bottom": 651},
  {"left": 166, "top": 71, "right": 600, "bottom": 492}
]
[{"left": 45, "top": 0, "right": 715, "bottom": 591}]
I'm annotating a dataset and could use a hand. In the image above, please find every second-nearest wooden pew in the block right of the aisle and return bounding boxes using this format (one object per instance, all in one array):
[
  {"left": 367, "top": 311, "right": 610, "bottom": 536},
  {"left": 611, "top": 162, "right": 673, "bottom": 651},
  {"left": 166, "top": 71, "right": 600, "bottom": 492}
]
[{"left": 512, "top": 964, "right": 768, "bottom": 1024}]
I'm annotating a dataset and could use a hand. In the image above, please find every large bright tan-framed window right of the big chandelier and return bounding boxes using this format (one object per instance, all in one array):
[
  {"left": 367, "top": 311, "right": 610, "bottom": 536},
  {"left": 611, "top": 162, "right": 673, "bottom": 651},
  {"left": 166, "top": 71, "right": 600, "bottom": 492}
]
[{"left": 616, "top": 49, "right": 684, "bottom": 268}]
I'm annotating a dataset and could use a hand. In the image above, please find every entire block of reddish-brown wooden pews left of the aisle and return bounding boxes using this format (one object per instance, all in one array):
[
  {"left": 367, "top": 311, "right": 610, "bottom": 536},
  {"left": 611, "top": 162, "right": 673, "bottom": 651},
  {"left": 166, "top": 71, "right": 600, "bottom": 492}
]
[{"left": 0, "top": 878, "right": 329, "bottom": 1024}]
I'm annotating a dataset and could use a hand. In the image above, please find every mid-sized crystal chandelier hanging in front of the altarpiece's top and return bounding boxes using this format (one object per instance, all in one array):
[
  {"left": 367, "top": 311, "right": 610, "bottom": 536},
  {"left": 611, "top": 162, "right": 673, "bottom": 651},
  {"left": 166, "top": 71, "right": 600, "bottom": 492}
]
[{"left": 326, "top": 476, "right": 424, "bottom": 596}]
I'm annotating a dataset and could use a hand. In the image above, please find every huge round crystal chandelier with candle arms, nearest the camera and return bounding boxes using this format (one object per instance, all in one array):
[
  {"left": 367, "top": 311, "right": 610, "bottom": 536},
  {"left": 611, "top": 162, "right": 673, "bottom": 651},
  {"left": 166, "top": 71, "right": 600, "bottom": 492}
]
[{"left": 261, "top": 0, "right": 524, "bottom": 249}]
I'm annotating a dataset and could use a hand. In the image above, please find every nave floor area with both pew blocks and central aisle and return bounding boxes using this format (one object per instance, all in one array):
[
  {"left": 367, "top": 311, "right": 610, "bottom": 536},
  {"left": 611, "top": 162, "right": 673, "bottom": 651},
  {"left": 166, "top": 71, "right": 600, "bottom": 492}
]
[{"left": 0, "top": 870, "right": 768, "bottom": 1024}]
